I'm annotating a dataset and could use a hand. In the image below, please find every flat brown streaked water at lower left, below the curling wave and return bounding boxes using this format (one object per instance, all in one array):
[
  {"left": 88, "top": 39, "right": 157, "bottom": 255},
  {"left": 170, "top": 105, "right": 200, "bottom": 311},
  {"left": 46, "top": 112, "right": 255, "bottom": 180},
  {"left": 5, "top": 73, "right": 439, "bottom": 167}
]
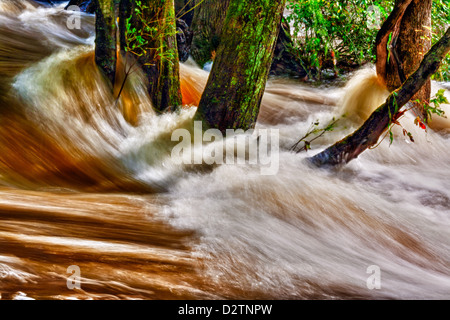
[{"left": 0, "top": 188, "right": 212, "bottom": 299}]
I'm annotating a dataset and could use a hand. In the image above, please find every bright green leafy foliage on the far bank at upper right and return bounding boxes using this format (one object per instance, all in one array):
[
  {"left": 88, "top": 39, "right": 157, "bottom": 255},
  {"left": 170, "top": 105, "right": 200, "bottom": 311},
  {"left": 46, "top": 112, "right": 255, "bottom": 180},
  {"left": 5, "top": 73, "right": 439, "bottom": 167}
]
[{"left": 287, "top": 0, "right": 450, "bottom": 81}]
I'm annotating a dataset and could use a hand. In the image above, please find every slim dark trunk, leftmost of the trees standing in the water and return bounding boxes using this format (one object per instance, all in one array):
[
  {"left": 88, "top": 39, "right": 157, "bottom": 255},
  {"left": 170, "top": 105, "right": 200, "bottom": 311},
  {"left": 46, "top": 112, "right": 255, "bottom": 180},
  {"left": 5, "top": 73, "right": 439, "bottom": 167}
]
[{"left": 95, "top": 0, "right": 119, "bottom": 85}]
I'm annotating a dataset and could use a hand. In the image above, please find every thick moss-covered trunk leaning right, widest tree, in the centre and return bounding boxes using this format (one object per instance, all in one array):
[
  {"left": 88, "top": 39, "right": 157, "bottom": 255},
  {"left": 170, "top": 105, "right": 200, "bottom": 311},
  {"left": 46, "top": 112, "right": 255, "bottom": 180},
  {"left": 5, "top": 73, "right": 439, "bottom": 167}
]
[{"left": 196, "top": 0, "right": 286, "bottom": 132}]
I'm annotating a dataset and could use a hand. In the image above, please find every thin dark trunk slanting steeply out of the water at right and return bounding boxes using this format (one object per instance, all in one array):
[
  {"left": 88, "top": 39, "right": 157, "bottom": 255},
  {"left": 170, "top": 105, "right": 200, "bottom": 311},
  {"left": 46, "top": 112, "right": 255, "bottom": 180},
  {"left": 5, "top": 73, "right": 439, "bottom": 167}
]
[{"left": 309, "top": 28, "right": 450, "bottom": 166}]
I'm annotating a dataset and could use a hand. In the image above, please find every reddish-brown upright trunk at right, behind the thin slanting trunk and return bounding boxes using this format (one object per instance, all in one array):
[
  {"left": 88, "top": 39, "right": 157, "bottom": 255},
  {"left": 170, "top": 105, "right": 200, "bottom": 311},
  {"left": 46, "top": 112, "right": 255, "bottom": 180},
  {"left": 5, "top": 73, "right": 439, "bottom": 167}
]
[{"left": 378, "top": 0, "right": 432, "bottom": 118}]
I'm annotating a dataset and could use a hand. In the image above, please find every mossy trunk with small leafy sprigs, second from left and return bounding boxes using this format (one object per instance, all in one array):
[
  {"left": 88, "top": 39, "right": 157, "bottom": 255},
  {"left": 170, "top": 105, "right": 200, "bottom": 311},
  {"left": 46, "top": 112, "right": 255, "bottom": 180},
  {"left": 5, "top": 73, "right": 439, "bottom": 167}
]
[{"left": 119, "top": 0, "right": 181, "bottom": 111}]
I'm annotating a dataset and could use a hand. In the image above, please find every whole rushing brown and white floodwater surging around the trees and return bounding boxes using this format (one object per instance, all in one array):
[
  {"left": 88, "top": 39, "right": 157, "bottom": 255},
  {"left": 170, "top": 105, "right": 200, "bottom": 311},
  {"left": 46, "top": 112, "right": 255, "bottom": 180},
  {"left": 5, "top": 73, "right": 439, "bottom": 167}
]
[{"left": 0, "top": 0, "right": 450, "bottom": 299}]
